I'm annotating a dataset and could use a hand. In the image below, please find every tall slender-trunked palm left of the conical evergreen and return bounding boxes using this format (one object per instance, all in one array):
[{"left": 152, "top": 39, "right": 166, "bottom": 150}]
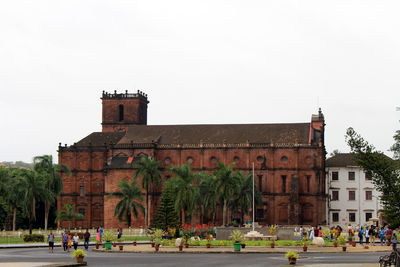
[{"left": 133, "top": 156, "right": 162, "bottom": 228}]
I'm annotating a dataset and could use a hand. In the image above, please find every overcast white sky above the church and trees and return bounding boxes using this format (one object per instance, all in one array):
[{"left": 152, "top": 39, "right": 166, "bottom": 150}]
[{"left": 0, "top": 0, "right": 400, "bottom": 162}]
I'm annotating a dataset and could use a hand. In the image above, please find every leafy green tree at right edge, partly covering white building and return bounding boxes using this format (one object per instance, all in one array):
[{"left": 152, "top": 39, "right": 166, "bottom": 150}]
[{"left": 346, "top": 128, "right": 400, "bottom": 228}]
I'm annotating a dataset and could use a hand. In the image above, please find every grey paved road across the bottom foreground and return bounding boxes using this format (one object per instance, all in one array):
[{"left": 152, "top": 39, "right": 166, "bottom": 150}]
[{"left": 0, "top": 248, "right": 387, "bottom": 267}]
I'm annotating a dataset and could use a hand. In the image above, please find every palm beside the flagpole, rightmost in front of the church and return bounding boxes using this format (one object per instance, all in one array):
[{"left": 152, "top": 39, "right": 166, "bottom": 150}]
[{"left": 231, "top": 171, "right": 262, "bottom": 223}]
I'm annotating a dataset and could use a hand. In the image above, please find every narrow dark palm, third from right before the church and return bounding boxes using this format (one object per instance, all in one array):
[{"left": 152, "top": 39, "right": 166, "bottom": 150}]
[{"left": 197, "top": 172, "right": 217, "bottom": 222}]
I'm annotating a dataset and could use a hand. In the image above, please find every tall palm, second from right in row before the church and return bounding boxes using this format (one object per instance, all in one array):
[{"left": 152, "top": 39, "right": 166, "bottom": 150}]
[{"left": 213, "top": 161, "right": 239, "bottom": 225}]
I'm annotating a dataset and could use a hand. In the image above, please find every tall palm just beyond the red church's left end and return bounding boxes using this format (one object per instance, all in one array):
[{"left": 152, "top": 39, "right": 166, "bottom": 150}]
[{"left": 33, "top": 155, "right": 71, "bottom": 230}]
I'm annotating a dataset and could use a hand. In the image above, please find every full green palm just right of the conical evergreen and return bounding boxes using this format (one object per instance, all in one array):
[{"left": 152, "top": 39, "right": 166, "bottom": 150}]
[{"left": 168, "top": 163, "right": 200, "bottom": 223}]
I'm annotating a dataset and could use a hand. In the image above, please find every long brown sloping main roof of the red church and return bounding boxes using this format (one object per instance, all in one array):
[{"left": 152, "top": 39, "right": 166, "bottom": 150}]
[{"left": 118, "top": 123, "right": 310, "bottom": 147}]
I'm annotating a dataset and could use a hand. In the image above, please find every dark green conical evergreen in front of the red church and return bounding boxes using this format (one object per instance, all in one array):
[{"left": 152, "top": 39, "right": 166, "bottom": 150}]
[{"left": 154, "top": 181, "right": 179, "bottom": 231}]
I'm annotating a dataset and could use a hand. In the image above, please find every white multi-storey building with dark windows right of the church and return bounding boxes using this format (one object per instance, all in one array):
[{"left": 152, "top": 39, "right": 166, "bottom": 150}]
[{"left": 325, "top": 153, "right": 382, "bottom": 226}]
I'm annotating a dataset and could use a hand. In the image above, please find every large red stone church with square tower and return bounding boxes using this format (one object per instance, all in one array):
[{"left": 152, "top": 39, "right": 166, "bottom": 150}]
[{"left": 58, "top": 91, "right": 326, "bottom": 228}]
